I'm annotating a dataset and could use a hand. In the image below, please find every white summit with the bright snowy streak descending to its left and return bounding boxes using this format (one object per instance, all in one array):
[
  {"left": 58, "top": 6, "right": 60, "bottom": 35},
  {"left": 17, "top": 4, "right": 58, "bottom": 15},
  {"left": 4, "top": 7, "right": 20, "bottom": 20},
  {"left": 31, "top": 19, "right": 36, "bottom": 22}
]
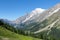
[{"left": 22, "top": 8, "right": 45, "bottom": 23}]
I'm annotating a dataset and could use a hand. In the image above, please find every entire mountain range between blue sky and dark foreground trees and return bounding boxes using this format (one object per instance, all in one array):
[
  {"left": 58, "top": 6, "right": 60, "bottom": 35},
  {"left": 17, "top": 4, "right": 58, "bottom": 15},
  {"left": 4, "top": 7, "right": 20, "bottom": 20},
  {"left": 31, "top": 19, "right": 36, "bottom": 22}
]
[{"left": 0, "top": 3, "right": 60, "bottom": 40}]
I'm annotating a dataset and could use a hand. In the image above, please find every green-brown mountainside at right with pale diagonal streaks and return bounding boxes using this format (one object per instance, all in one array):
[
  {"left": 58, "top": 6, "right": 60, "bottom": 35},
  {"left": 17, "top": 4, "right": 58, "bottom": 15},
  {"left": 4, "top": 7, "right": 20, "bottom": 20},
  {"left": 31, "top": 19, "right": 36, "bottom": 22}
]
[{"left": 32, "top": 5, "right": 60, "bottom": 40}]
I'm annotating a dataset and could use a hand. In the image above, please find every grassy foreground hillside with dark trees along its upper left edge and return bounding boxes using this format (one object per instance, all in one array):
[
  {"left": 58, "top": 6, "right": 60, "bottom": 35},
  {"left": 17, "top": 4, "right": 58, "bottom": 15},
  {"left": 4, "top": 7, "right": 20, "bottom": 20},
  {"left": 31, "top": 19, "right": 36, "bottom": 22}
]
[{"left": 0, "top": 20, "right": 41, "bottom": 40}]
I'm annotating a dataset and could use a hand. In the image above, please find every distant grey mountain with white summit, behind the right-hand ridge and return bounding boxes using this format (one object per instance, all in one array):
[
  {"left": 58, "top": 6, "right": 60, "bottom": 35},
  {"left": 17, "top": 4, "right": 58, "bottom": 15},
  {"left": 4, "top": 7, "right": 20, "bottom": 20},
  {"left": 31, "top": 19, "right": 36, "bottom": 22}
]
[{"left": 14, "top": 8, "right": 45, "bottom": 24}]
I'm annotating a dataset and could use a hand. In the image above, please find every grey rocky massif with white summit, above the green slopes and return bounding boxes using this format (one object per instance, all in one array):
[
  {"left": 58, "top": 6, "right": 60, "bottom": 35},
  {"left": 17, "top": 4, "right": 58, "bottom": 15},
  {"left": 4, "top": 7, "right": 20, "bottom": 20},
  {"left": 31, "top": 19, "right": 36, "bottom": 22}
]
[{"left": 14, "top": 4, "right": 60, "bottom": 27}]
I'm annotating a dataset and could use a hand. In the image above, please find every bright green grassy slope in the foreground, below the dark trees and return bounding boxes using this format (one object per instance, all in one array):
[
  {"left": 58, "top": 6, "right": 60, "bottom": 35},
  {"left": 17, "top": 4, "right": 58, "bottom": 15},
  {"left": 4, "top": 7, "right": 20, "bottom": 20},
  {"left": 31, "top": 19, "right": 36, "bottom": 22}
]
[{"left": 0, "top": 26, "right": 40, "bottom": 40}]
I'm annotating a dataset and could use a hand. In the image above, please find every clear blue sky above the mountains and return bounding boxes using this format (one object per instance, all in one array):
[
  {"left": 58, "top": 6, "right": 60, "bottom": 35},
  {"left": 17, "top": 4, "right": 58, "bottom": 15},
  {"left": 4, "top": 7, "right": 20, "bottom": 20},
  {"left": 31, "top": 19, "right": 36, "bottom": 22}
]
[{"left": 0, "top": 0, "right": 60, "bottom": 20}]
